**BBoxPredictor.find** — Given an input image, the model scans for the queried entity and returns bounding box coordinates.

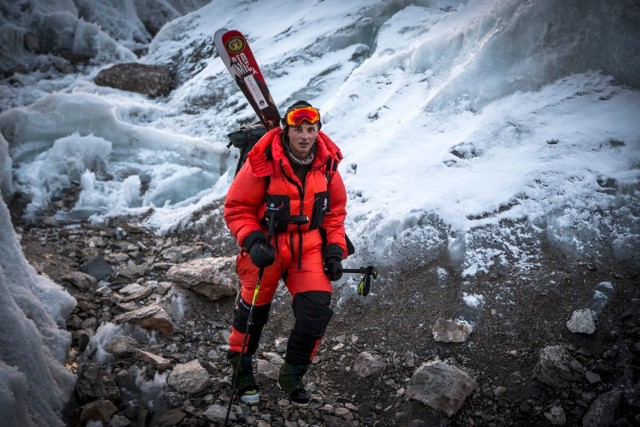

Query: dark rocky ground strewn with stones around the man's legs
[8,192,640,427]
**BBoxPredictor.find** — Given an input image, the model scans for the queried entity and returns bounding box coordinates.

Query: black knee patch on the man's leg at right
[292,291,333,339]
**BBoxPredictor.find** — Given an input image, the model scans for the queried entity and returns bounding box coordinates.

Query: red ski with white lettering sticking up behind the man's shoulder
[214,28,280,130]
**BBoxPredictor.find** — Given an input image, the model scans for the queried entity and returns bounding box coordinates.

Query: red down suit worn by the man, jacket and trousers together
[224,128,347,363]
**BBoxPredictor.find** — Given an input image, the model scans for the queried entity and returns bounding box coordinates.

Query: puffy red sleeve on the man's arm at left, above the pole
[224,162,267,245]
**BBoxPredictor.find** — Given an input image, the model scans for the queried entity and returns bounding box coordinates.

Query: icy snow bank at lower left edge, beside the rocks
[0,137,76,426]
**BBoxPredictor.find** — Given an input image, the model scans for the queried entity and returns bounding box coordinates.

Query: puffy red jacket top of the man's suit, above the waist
[224,128,347,258]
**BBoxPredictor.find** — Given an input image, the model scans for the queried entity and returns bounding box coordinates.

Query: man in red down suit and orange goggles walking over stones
[224,101,347,405]
